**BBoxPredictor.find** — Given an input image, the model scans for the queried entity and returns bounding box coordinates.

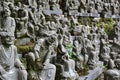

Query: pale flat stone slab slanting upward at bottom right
[79,62,103,80]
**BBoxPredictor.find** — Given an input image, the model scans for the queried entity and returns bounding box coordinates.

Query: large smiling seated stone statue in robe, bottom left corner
[0,34,27,80]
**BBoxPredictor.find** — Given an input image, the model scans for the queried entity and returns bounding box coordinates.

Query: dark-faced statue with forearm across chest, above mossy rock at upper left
[15,7,28,37]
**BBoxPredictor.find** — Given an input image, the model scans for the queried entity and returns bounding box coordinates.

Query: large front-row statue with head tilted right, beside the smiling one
[27,37,56,80]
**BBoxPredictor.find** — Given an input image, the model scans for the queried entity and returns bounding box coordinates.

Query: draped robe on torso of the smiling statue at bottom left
[0,45,18,80]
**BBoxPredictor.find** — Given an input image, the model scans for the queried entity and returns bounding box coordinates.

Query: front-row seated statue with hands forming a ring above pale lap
[55,44,78,80]
